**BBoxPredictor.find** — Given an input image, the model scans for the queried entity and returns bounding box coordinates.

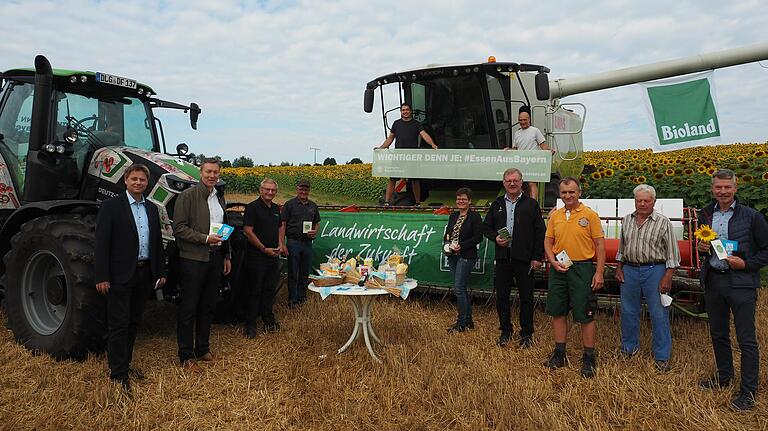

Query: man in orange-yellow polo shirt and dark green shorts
[544,177,605,377]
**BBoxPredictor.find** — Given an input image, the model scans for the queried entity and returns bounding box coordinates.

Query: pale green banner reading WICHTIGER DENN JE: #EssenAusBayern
[371,149,552,182]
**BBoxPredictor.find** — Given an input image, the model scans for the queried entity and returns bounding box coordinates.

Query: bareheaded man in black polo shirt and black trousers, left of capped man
[243,178,285,338]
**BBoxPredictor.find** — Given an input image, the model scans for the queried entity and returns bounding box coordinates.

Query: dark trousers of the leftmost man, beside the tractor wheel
[107,265,152,380]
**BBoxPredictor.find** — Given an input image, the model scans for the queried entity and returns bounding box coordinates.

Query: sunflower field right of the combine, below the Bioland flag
[580,143,768,214]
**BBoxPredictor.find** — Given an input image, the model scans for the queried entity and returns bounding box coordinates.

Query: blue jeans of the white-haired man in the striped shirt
[621,264,672,361]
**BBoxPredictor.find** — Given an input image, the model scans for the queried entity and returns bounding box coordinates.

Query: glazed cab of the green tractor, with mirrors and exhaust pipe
[0,65,200,202]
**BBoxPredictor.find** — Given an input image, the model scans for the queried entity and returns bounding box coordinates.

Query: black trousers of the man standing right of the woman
[493,260,534,337]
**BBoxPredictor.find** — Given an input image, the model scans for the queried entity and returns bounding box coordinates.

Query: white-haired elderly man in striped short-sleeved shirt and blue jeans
[616,184,680,372]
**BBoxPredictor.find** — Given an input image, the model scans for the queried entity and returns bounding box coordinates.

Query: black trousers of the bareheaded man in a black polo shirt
[245,253,280,329]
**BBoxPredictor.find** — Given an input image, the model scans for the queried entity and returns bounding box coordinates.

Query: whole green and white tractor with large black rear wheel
[0,56,201,358]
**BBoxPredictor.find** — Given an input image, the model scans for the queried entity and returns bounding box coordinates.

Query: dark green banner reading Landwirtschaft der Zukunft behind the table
[312,211,494,290]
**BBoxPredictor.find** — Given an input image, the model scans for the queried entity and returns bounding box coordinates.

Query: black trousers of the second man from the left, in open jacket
[176,251,224,363]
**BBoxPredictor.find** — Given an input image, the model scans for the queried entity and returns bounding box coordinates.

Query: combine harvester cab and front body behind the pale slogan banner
[364,57,586,206]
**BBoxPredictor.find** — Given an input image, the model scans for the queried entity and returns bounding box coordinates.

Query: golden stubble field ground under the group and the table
[0,290,768,431]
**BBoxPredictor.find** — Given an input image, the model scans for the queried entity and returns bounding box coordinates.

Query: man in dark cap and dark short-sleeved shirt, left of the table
[281,180,320,308]
